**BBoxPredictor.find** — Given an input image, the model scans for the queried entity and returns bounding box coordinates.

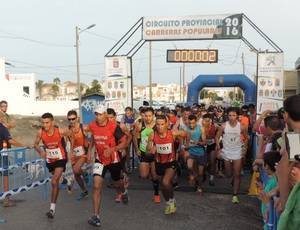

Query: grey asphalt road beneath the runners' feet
[0,171,262,230]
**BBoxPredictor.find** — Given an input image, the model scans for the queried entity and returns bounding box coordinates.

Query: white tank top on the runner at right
[222,121,242,152]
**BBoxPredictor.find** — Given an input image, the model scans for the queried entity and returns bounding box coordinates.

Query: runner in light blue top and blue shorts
[186,115,207,194]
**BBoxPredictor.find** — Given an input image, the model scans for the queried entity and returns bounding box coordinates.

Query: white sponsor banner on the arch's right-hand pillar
[257,53,284,114]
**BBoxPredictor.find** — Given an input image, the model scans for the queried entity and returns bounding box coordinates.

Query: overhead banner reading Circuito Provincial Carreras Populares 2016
[143,14,243,40]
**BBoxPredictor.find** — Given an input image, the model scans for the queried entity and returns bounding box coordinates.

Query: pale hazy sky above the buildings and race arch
[0,0,300,84]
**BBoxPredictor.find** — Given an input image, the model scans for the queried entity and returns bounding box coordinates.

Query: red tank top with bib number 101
[153,130,176,164]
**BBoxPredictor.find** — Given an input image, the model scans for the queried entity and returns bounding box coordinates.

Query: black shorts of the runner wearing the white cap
[93,160,122,181]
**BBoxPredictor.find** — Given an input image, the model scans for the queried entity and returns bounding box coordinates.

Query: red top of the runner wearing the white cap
[89,121,120,165]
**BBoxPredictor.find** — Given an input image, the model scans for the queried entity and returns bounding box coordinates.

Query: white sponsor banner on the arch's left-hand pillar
[105,56,131,114]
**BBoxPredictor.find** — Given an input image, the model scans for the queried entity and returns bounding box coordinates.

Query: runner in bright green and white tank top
[134,107,160,203]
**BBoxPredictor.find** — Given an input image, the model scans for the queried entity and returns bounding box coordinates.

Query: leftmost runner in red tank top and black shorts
[34,113,68,219]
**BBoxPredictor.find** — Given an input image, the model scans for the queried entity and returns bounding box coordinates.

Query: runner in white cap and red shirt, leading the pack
[85,105,128,227]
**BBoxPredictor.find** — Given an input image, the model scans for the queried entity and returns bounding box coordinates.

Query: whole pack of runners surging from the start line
[1,101,251,227]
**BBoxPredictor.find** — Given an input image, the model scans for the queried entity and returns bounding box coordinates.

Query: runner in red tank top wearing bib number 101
[147,115,186,215]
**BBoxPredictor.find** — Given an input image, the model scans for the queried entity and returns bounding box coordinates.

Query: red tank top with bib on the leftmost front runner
[41,127,67,163]
